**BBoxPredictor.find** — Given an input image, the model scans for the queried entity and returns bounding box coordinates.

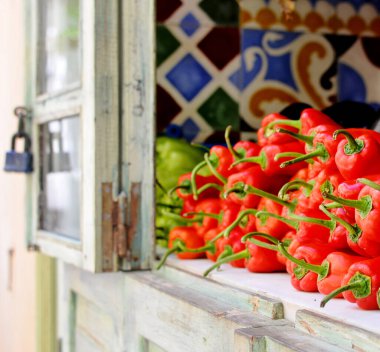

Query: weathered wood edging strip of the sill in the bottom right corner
[295,307,380,352]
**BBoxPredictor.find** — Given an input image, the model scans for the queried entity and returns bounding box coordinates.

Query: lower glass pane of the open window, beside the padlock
[39,116,81,239]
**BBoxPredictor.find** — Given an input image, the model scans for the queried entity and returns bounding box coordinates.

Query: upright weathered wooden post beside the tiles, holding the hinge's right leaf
[121,0,156,270]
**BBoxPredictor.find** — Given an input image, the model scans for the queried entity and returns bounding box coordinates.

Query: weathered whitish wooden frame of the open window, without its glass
[25,0,120,272]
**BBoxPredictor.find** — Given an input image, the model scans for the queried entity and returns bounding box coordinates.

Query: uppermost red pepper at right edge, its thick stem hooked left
[333,130,380,180]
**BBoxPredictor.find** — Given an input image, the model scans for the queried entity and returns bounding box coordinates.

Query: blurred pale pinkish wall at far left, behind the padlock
[0,0,36,352]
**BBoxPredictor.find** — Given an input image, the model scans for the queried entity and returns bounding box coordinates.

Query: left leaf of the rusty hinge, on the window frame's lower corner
[102,182,128,271]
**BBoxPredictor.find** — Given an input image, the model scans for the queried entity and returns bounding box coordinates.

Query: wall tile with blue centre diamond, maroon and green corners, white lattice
[157,23,240,142]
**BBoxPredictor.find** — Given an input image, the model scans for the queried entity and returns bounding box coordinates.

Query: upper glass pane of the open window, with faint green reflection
[37,0,81,95]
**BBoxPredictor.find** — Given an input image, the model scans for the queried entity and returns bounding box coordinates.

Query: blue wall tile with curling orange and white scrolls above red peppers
[240,29,352,132]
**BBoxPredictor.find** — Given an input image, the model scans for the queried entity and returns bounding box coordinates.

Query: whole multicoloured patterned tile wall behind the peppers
[157,0,380,142]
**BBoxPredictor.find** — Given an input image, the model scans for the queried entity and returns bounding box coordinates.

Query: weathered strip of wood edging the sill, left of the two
[156,264,284,319]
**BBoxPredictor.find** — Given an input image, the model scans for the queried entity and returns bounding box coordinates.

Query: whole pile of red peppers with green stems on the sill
[158,108,380,309]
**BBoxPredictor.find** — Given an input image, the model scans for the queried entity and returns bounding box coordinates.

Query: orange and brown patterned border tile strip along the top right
[240,0,380,36]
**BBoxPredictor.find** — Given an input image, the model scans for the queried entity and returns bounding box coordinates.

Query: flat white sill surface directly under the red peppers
[167,256,380,337]
